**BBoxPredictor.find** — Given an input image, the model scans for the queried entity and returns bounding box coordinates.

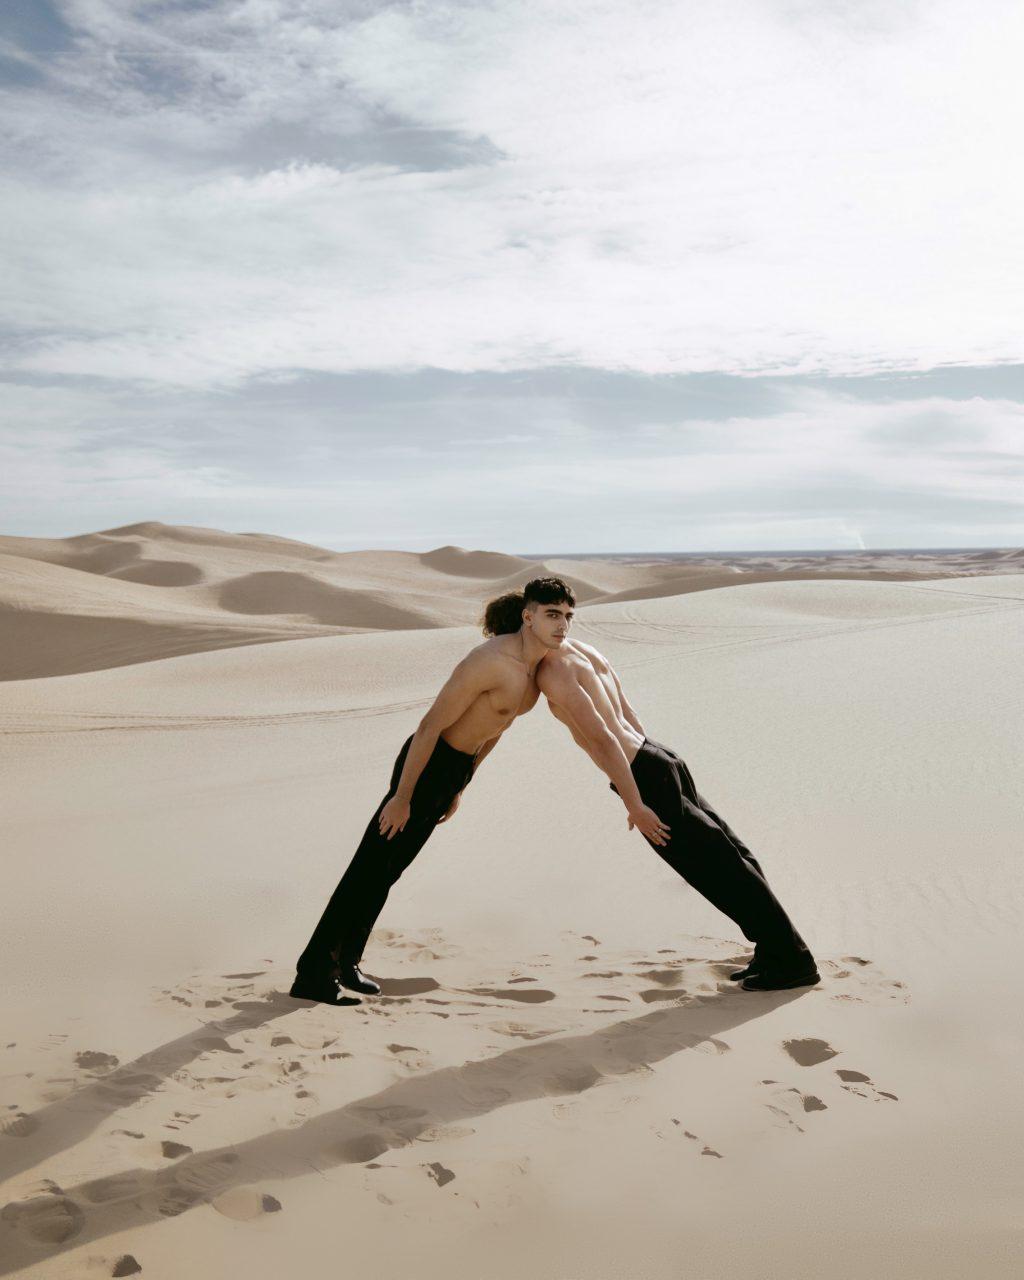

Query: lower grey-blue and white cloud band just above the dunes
[0,371,1024,552]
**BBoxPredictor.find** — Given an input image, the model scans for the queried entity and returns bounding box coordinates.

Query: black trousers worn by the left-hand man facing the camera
[296,736,476,978]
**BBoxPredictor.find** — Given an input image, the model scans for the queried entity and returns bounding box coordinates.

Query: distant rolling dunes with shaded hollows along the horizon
[0,521,1024,680]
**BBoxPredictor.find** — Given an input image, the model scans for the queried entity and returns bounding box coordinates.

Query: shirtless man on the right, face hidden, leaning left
[536,605,819,991]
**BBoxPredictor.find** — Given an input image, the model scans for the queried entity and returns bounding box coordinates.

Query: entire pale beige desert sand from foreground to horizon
[0,525,1024,1280]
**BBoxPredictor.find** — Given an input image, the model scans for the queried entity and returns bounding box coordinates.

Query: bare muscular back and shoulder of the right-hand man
[538,640,644,763]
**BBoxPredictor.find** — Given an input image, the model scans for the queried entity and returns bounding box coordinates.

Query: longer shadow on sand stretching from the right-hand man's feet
[0,991,805,1275]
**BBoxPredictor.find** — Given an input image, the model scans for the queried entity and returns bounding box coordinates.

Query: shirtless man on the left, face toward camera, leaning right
[289,577,575,1004]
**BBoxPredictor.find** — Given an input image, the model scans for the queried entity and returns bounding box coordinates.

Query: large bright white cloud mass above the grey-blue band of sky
[0,0,1024,389]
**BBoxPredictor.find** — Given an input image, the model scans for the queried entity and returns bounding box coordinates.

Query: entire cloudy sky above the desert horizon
[0,0,1024,552]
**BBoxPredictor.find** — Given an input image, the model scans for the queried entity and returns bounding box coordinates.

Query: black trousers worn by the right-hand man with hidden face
[612,737,812,968]
